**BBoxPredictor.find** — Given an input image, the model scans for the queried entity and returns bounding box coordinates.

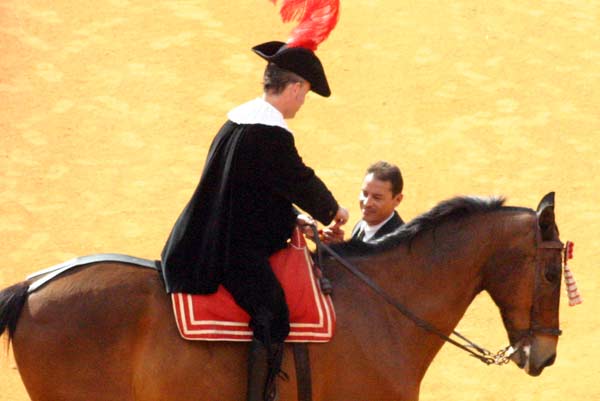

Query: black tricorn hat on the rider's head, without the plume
[252,41,331,97]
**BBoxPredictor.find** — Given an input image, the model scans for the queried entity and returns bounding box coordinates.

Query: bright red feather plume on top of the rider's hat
[271,0,340,51]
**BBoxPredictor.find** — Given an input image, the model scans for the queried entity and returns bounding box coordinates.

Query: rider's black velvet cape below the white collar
[162,121,338,294]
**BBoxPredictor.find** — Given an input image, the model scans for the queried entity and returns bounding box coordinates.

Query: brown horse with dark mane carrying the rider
[0,194,562,401]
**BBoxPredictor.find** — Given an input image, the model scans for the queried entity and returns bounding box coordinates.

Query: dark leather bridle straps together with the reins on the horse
[308,224,565,365]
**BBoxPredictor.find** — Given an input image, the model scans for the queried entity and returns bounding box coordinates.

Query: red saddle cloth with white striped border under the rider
[171,229,335,342]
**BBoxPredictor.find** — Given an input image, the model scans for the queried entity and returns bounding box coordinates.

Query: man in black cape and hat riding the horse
[162,42,348,400]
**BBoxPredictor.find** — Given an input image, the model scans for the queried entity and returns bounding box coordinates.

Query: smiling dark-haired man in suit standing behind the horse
[322,161,404,243]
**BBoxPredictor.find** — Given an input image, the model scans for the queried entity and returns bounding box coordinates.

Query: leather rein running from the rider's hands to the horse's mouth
[308,224,563,365]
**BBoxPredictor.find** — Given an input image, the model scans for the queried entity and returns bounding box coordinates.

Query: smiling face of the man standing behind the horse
[358,173,402,226]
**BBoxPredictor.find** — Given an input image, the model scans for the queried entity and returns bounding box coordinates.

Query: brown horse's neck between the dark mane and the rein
[359,215,498,320]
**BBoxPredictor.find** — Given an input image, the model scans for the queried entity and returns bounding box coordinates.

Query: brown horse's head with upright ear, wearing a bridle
[486,192,564,376]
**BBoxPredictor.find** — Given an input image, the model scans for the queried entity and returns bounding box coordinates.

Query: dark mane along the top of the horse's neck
[331,196,524,256]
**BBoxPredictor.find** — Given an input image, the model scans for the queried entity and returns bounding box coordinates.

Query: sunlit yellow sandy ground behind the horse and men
[0,0,600,401]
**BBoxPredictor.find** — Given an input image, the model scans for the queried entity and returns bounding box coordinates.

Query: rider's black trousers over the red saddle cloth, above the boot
[223,260,290,346]
